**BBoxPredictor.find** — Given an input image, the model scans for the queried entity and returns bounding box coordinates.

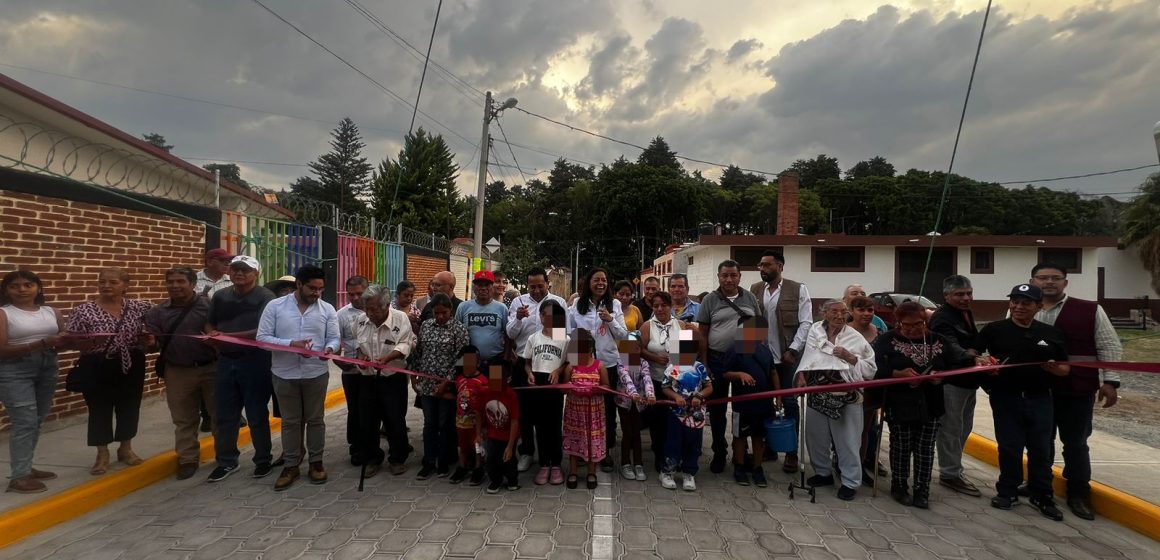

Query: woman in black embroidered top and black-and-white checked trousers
[873,301,985,509]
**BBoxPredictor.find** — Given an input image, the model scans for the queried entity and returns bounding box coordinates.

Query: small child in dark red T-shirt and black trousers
[476,364,520,494]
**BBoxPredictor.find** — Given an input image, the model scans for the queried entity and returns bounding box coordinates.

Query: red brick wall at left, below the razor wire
[0,189,205,429]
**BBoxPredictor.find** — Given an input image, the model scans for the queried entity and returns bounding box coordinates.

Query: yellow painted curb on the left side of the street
[0,387,346,548]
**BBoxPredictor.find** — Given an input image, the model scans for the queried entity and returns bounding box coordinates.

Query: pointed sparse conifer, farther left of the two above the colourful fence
[290,117,374,213]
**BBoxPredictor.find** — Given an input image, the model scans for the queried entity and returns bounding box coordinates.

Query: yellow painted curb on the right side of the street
[963,434,1160,540]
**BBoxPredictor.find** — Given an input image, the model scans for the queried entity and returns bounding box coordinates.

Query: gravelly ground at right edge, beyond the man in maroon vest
[1094,330,1160,448]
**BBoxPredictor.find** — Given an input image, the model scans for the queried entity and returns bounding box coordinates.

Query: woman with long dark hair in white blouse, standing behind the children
[567,268,629,473]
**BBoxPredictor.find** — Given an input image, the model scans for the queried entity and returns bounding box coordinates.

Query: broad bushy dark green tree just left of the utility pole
[370,128,464,239]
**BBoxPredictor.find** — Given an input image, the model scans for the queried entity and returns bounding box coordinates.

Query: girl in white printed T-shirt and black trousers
[523,299,568,486]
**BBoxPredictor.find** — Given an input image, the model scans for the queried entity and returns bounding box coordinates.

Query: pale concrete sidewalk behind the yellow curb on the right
[974,391,1160,506]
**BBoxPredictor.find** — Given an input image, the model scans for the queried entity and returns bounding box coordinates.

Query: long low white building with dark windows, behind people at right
[672,234,1158,320]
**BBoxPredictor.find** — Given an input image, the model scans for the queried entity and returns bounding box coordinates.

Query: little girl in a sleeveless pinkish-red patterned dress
[563,328,608,489]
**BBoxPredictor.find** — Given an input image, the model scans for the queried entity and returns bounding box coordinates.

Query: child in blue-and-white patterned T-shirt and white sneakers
[660,340,713,492]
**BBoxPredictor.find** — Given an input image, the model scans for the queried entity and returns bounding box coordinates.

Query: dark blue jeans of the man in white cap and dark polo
[213,350,274,467]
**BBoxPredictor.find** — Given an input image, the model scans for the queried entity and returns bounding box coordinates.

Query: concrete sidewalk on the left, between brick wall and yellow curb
[0,365,346,516]
